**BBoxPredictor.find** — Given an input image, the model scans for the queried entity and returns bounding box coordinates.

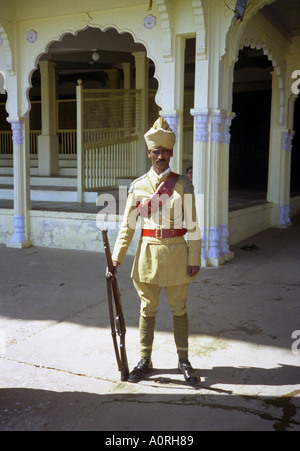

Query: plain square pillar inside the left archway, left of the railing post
[38,61,59,177]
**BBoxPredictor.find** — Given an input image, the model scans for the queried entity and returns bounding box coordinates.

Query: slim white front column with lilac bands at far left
[7,119,31,249]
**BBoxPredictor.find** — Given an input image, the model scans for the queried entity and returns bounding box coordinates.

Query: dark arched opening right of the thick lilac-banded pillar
[229,47,272,198]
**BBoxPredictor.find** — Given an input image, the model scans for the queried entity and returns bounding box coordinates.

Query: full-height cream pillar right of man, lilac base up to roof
[191,0,234,266]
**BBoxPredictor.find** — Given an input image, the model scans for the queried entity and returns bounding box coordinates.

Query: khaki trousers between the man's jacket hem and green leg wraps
[133,280,189,317]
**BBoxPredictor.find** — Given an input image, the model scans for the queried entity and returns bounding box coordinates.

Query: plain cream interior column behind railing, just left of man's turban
[133,52,149,174]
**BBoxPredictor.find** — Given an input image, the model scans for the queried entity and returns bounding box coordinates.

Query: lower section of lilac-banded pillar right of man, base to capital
[191,108,234,266]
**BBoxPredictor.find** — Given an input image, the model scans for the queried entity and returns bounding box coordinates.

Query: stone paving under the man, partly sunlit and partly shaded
[0,216,300,437]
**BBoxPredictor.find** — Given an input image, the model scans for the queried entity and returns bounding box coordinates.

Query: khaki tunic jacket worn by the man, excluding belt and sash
[112,169,201,286]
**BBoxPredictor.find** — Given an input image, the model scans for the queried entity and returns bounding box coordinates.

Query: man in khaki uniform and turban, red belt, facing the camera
[112,117,201,384]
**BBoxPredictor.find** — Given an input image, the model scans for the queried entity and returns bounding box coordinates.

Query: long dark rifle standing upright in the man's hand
[102,230,129,381]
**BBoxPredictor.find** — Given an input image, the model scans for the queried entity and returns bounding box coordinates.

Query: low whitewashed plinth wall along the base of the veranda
[0,202,300,255]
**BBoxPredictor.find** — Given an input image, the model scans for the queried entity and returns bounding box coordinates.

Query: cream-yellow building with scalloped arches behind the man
[0,0,300,266]
